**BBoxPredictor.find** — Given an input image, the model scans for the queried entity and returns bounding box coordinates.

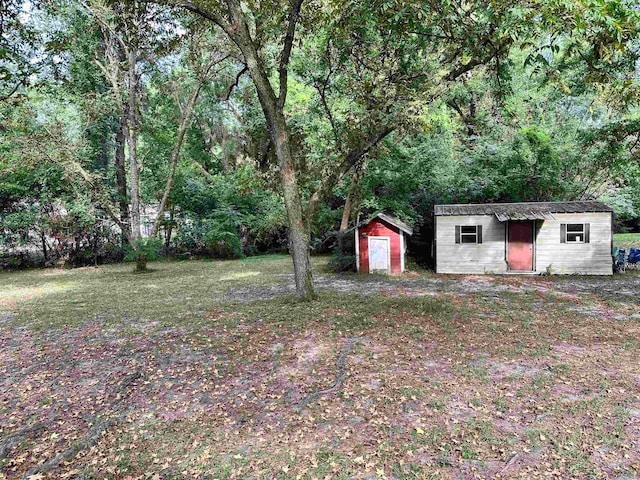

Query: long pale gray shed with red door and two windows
[434,202,613,275]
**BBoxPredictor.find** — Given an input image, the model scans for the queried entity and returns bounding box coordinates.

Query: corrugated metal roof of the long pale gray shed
[434,201,613,221]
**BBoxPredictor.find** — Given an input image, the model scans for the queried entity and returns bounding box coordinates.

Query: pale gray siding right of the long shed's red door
[536,212,613,275]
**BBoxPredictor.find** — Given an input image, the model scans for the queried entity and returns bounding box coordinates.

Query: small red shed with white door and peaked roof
[355,213,413,274]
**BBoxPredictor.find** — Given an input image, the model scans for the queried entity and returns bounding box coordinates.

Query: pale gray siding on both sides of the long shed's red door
[436,212,613,275]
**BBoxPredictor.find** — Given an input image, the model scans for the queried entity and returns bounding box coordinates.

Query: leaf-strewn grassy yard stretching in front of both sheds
[0,258,640,479]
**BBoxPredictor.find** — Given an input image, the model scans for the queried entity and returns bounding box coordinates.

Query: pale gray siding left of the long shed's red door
[436,215,507,273]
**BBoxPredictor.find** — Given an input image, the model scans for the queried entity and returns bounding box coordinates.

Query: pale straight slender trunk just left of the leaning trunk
[126,48,141,244]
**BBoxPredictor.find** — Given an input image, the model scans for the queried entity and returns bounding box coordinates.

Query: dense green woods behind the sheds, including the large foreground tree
[0,0,640,297]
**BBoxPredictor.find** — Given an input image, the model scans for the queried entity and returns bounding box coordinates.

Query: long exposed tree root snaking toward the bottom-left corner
[22,371,142,479]
